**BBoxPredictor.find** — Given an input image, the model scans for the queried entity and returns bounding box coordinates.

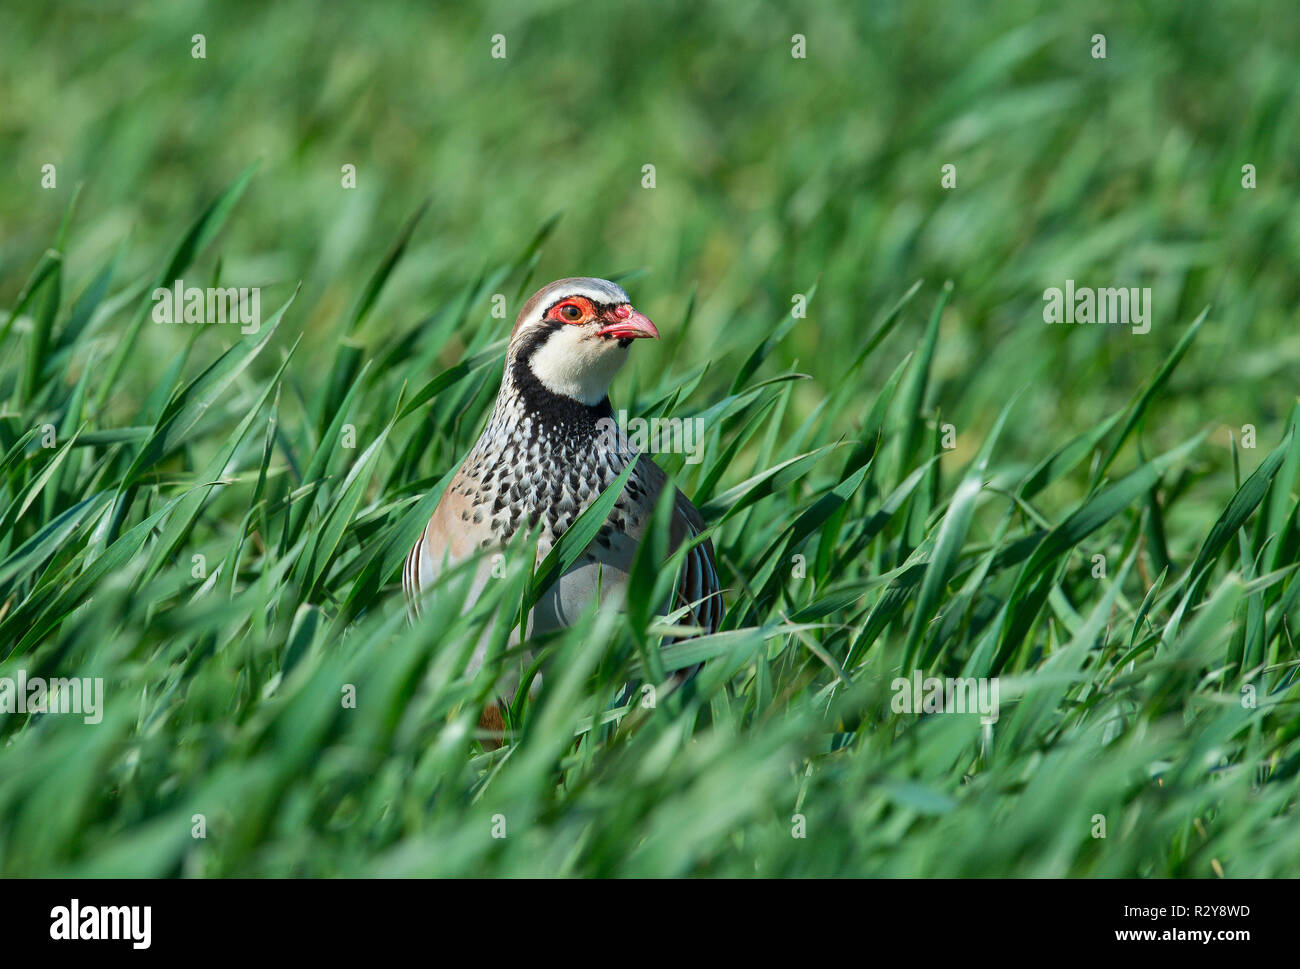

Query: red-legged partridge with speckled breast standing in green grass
[402,277,724,732]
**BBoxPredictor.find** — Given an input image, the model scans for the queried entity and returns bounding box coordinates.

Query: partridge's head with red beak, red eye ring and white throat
[506,277,659,406]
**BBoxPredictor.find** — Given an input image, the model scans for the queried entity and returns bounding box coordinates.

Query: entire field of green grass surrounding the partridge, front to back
[0,3,1300,877]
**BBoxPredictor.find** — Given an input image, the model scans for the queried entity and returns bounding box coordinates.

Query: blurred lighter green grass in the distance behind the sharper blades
[0,1,1300,454]
